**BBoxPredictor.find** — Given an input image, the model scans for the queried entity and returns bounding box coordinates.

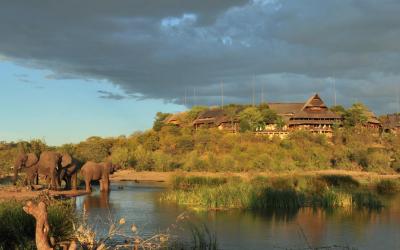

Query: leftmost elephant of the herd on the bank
[14,153,39,185]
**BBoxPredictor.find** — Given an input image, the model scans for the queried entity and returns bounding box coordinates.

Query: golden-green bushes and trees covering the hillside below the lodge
[0,102,400,175]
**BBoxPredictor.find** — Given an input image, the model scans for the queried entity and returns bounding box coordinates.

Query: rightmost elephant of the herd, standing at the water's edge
[81,161,117,193]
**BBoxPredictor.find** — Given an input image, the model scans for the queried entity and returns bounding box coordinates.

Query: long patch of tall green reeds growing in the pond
[161,176,383,211]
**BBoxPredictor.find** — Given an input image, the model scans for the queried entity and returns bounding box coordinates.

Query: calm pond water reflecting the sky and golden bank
[76,182,400,250]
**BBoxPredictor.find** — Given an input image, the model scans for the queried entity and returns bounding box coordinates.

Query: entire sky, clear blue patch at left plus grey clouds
[0,0,400,145]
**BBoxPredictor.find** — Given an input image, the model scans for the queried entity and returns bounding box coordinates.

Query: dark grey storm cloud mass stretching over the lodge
[0,0,400,112]
